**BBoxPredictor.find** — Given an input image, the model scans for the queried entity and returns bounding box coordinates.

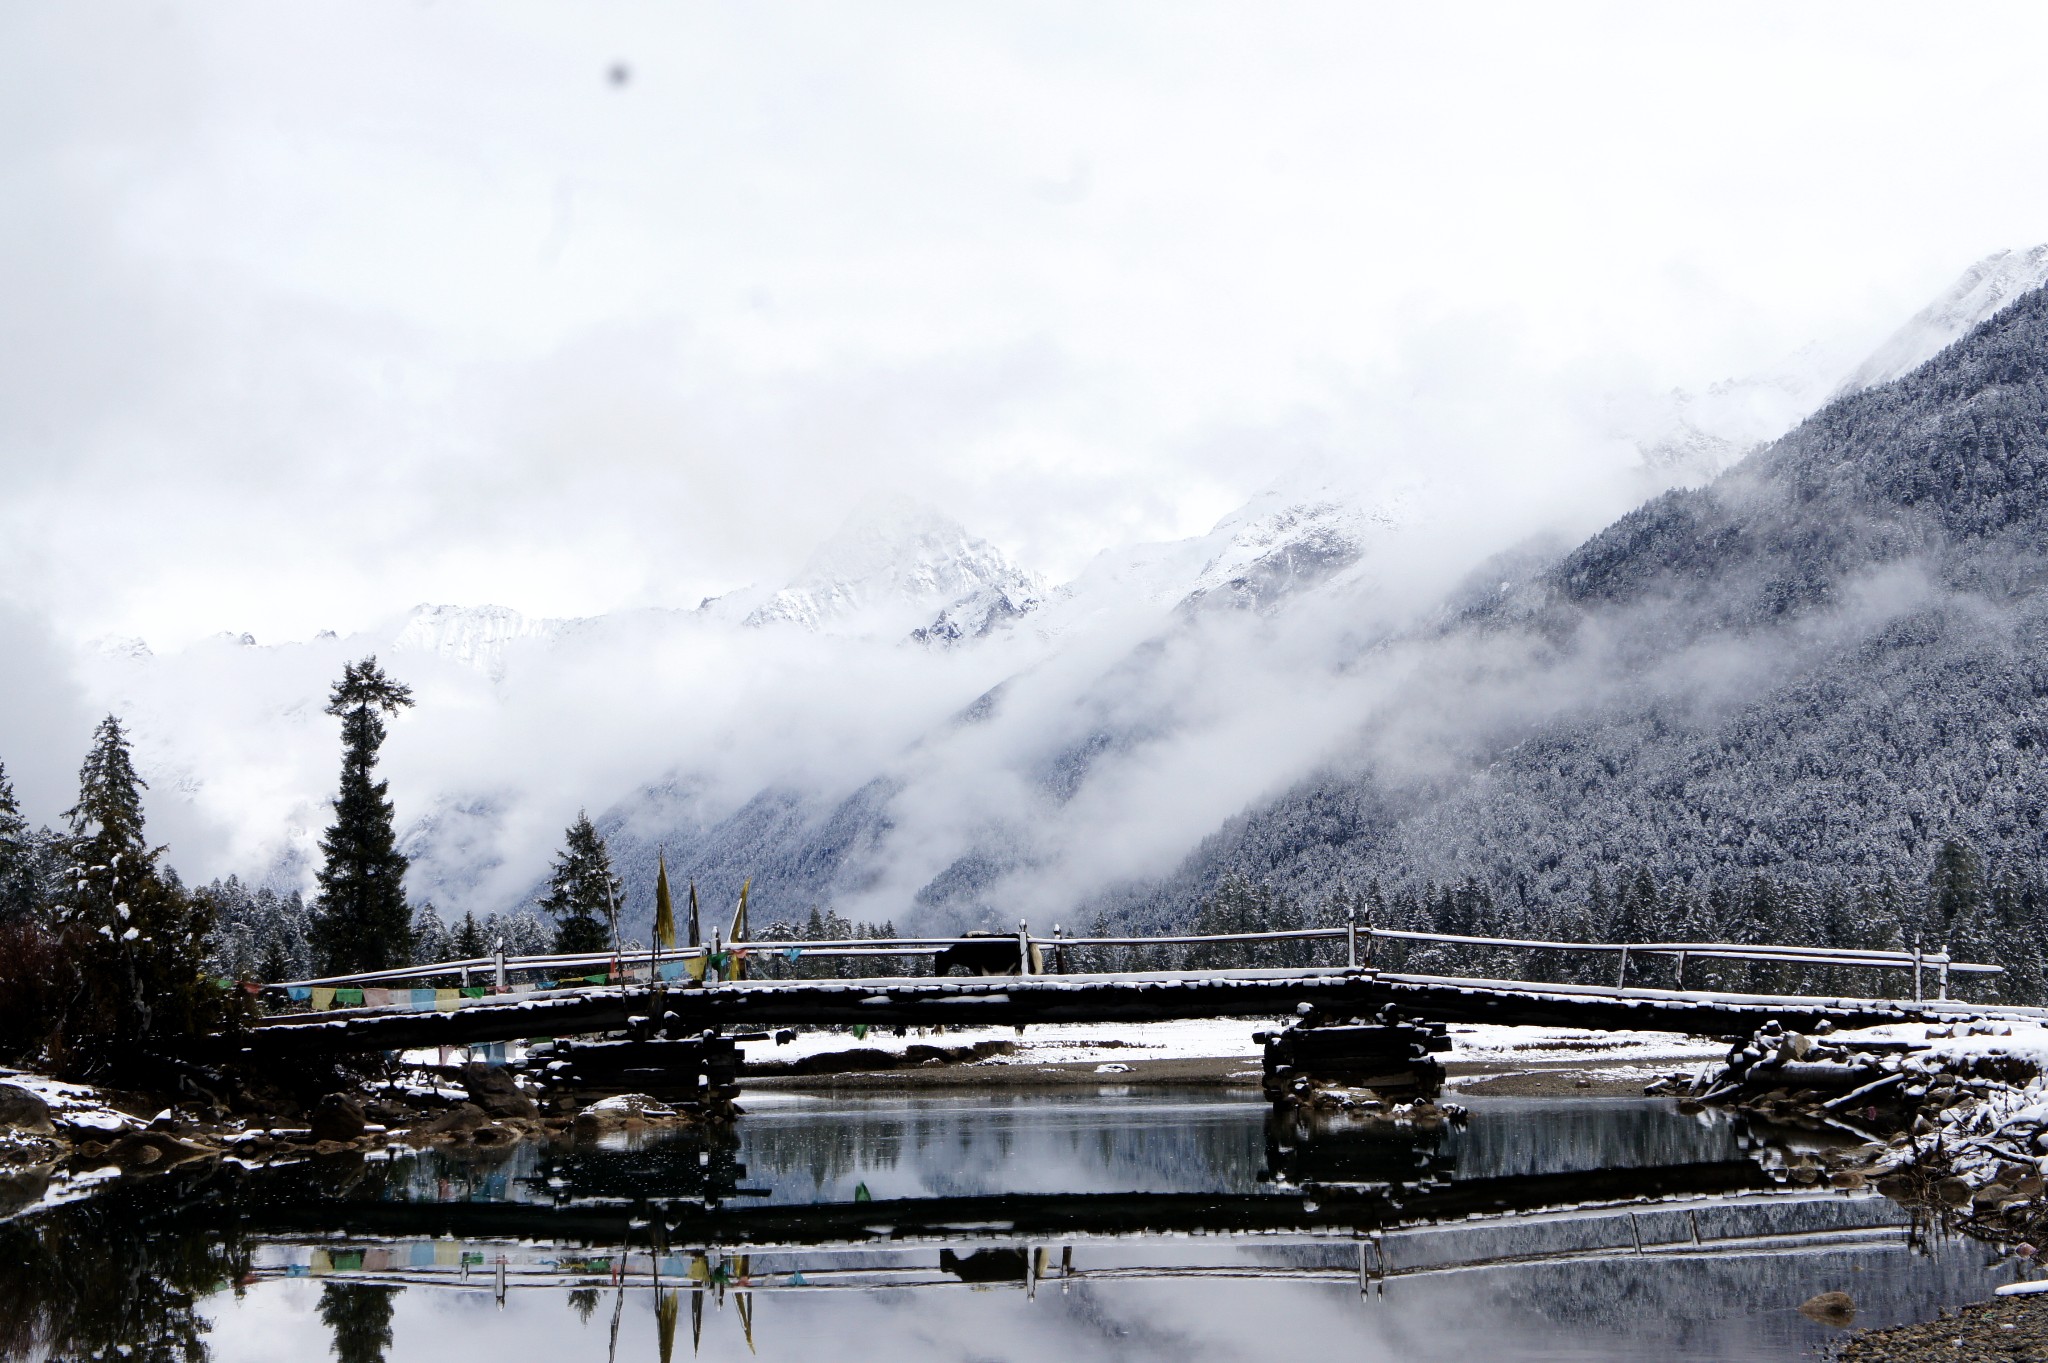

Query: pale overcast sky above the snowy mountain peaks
[0,0,2048,647]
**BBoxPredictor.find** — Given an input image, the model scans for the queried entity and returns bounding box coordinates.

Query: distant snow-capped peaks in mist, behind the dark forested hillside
[59,248,2048,925]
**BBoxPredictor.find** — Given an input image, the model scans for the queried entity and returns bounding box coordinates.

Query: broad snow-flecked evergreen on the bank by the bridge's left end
[57,714,225,1072]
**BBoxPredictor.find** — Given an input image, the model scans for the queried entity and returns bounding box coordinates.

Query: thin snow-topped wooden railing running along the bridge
[264,919,2003,1007]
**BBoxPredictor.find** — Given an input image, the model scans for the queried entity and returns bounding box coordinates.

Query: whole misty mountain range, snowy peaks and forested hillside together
[44,250,2048,941]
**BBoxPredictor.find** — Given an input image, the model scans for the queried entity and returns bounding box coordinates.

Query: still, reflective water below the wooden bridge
[0,1093,2015,1363]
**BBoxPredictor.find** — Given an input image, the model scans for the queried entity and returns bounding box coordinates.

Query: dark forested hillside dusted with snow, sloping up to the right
[1096,291,2048,961]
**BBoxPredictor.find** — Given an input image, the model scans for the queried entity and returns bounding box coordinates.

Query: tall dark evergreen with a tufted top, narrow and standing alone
[313,657,412,974]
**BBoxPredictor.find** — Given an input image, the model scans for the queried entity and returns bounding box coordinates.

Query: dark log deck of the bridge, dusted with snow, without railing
[228,968,2048,1056]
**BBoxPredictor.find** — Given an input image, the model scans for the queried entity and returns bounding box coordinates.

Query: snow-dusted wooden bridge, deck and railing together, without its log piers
[238,923,2023,1056]
